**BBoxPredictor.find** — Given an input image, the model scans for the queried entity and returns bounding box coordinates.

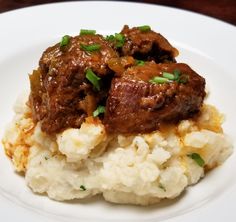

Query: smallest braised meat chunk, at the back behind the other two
[121,25,178,63]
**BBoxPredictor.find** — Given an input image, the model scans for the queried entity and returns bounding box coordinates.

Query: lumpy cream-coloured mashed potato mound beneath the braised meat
[3,92,232,205]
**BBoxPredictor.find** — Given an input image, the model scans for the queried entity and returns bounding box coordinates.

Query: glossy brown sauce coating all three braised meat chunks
[29,26,205,134]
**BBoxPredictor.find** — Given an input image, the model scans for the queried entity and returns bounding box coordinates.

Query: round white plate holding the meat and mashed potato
[0,2,236,222]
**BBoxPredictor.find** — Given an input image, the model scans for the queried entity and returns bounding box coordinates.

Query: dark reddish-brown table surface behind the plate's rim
[0,0,236,25]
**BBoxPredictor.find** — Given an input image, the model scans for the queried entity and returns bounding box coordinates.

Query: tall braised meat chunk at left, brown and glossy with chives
[30,34,118,133]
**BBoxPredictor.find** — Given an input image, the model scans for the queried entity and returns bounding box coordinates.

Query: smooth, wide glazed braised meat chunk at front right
[104,62,205,134]
